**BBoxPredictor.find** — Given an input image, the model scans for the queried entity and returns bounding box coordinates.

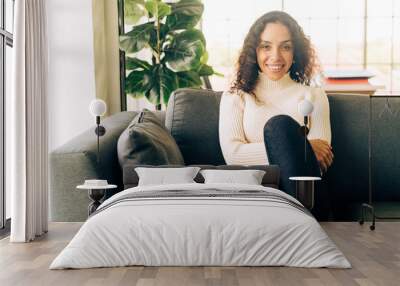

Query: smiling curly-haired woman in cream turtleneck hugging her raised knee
[219,11,333,219]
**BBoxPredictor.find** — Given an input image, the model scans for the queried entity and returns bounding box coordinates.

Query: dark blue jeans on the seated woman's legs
[264,115,330,220]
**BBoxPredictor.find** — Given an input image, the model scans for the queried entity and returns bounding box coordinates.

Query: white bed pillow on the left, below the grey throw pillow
[135,167,200,186]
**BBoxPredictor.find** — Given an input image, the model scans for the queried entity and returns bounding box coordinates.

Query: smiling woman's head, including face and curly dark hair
[233,11,317,92]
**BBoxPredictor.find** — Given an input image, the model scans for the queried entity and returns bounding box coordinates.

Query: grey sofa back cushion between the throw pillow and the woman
[165,88,225,165]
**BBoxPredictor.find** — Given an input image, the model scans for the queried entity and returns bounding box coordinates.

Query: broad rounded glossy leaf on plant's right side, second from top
[164,29,205,72]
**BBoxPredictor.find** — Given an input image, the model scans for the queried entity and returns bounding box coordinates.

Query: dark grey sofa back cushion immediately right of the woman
[326,94,369,205]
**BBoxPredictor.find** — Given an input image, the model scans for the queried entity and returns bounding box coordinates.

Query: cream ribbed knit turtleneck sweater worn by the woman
[219,73,331,165]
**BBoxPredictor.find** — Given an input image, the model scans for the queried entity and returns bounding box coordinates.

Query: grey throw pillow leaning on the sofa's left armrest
[117,109,184,168]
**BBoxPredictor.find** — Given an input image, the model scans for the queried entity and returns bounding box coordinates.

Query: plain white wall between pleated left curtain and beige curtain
[47,0,95,151]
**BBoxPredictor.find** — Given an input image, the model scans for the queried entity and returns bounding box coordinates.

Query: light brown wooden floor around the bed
[0,222,400,286]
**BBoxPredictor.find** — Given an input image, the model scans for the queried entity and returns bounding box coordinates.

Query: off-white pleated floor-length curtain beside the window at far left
[10,0,48,242]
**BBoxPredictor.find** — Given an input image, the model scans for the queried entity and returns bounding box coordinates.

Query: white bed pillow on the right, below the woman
[200,170,265,185]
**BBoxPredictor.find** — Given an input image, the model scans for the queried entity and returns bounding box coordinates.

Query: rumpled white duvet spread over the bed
[50,184,351,269]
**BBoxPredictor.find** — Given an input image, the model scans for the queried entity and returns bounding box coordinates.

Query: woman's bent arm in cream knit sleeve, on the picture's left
[219,92,268,165]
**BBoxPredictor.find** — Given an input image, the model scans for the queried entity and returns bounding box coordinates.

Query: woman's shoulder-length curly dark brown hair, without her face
[231,11,318,94]
